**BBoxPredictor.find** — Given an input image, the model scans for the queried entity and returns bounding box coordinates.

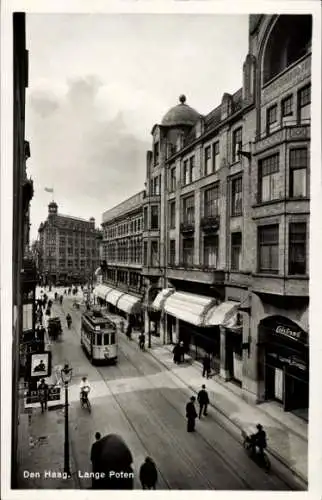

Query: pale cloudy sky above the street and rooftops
[26,14,248,239]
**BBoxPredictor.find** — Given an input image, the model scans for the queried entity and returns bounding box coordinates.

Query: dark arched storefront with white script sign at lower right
[259,316,309,419]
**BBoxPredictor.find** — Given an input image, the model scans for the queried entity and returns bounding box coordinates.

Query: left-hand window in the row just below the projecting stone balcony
[259,153,280,202]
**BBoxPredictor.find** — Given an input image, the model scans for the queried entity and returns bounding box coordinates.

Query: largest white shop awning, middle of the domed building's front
[164,292,215,326]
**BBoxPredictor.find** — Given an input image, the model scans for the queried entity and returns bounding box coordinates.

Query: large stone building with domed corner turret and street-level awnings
[142,15,312,415]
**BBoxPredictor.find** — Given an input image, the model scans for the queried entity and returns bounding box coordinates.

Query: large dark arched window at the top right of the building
[263,15,312,84]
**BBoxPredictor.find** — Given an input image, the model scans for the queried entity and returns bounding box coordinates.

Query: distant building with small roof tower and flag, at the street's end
[38,201,102,285]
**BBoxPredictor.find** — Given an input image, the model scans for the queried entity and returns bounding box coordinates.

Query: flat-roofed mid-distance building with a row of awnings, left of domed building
[95,191,145,323]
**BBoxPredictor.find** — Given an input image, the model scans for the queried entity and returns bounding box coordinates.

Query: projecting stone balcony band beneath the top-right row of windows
[254,124,311,155]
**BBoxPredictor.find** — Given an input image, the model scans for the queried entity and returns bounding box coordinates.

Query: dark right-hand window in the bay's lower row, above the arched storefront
[288,222,306,274]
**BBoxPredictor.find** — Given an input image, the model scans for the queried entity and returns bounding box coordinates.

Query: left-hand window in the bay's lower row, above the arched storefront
[258,224,279,274]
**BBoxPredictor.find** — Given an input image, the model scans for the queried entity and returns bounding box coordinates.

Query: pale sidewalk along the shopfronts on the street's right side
[133,332,308,483]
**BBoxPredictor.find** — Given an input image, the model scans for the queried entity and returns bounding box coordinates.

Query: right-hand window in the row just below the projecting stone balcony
[290,148,308,198]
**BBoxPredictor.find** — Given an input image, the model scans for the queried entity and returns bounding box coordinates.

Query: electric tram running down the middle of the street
[81,309,117,364]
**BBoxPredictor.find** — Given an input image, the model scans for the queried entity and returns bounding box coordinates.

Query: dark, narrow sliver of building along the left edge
[8,13,37,488]
